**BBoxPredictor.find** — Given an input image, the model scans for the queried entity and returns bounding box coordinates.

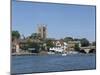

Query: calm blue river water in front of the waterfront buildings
[11,54,96,74]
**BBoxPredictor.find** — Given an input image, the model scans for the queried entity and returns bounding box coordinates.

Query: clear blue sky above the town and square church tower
[12,1,96,41]
